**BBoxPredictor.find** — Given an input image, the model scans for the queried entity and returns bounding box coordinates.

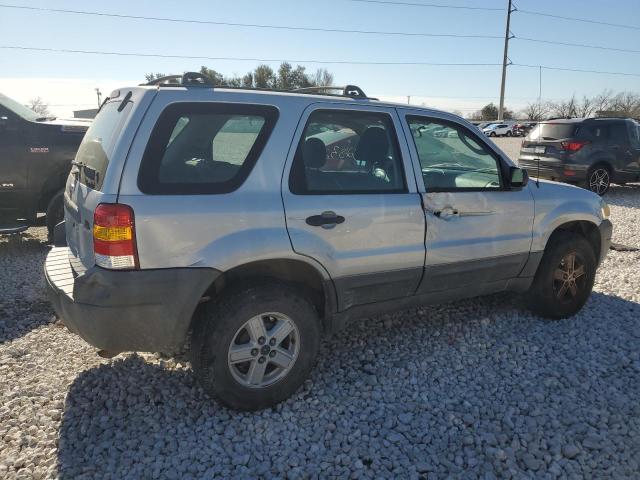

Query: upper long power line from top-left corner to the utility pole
[0,3,502,39]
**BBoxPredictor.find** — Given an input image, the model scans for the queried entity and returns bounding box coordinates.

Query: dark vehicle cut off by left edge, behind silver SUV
[0,94,90,234]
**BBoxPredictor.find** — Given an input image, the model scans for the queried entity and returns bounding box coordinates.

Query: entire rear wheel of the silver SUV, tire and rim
[191,282,320,410]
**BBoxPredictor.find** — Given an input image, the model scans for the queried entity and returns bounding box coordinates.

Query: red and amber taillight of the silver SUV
[93,203,139,270]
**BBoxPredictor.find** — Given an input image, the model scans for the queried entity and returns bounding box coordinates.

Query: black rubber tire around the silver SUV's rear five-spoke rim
[191,281,321,411]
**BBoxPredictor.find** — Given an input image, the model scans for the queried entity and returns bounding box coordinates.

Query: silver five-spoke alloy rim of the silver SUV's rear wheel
[227,312,300,388]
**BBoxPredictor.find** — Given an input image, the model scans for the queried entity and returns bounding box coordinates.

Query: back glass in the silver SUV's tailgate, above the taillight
[76,99,132,190]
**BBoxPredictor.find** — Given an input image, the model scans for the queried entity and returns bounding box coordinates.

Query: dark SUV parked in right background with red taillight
[518,118,640,195]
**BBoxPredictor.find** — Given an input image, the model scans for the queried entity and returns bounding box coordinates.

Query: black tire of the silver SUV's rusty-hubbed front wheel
[527,231,597,320]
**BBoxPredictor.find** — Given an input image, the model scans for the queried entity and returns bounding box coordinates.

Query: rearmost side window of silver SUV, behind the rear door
[138,103,278,195]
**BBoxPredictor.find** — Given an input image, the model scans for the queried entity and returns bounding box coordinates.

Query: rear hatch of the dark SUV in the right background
[520,122,580,164]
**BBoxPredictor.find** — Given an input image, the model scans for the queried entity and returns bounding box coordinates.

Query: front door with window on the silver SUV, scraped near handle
[403,110,534,293]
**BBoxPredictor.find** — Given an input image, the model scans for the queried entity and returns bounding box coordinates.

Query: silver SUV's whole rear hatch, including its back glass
[64,90,144,274]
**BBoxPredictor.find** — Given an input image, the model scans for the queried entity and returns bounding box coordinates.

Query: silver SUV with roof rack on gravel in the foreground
[45,75,612,410]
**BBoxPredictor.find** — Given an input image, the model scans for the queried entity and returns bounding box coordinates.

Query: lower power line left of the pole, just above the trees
[0,45,501,67]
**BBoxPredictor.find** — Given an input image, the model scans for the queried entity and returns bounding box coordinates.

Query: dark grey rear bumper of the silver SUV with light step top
[45,247,220,353]
